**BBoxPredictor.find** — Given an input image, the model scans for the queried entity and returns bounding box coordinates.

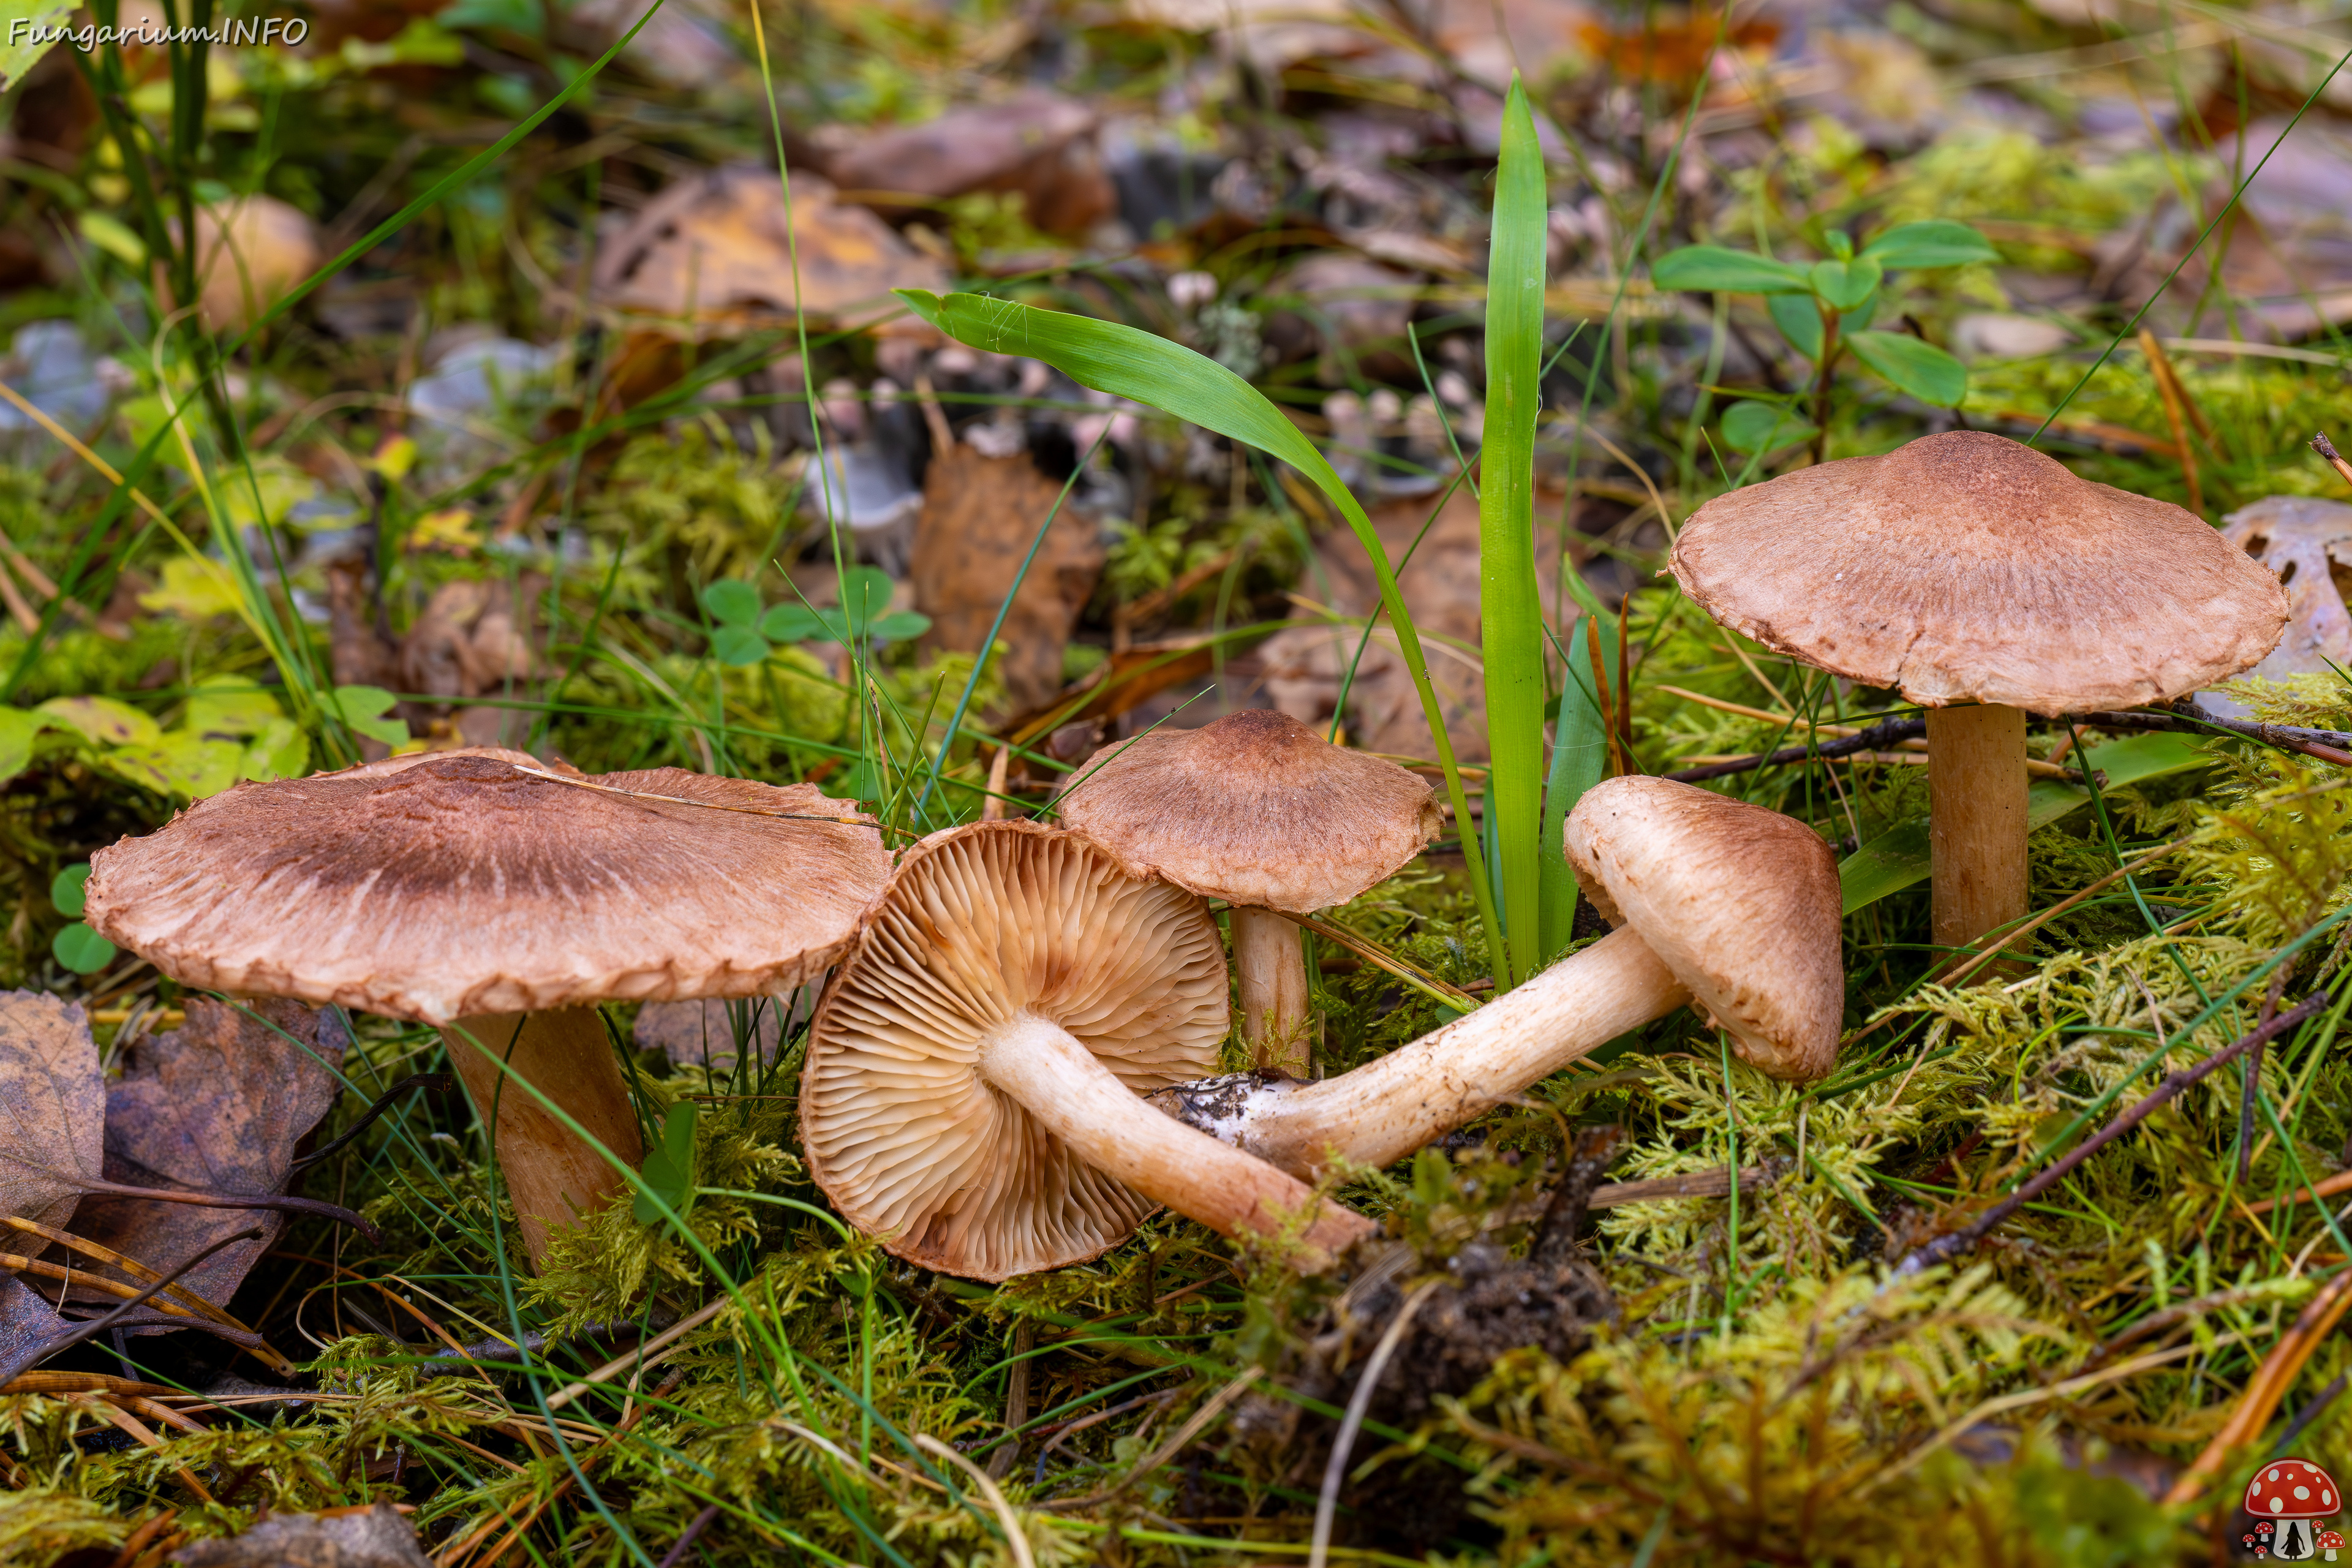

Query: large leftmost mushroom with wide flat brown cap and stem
[85,757,889,1265]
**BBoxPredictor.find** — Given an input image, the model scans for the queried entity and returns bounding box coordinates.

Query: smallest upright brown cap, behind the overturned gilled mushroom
[1058,707,1444,914]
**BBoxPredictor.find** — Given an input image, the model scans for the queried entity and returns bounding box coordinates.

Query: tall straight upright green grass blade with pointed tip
[1477,80,1548,990]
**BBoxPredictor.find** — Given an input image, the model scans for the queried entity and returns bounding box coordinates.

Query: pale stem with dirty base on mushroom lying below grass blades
[1153,926,1691,1180]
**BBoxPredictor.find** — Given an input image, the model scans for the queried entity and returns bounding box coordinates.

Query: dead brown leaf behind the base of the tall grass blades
[1258,486,1559,762]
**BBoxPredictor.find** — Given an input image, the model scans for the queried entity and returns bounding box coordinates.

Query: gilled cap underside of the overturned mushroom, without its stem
[800,823,1227,1281]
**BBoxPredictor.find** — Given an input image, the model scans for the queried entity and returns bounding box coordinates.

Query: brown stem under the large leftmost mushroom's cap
[442,1006,644,1270]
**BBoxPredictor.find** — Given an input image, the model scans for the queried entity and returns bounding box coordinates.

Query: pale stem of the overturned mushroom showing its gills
[981,1013,1374,1267]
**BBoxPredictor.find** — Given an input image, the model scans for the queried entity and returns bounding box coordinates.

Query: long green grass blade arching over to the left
[896,289,1507,985]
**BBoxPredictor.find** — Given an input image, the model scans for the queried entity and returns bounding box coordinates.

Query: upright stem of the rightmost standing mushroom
[1926,703,2030,978]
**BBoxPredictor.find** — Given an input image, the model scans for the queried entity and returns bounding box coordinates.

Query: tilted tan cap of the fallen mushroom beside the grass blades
[1566,778,1846,1079]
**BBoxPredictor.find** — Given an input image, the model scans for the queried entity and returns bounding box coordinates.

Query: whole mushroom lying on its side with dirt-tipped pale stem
[1153,776,1846,1180]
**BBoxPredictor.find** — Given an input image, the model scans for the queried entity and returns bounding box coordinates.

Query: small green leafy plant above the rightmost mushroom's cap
[1649,219,1997,456]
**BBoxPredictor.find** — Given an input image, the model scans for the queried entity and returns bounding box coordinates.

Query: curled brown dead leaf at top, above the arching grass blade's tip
[823,89,1117,239]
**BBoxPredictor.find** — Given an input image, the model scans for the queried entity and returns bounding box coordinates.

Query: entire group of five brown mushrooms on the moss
[87,432,2286,1281]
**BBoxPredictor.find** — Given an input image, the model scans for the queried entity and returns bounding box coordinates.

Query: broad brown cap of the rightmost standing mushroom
[1670,430,2286,715]
